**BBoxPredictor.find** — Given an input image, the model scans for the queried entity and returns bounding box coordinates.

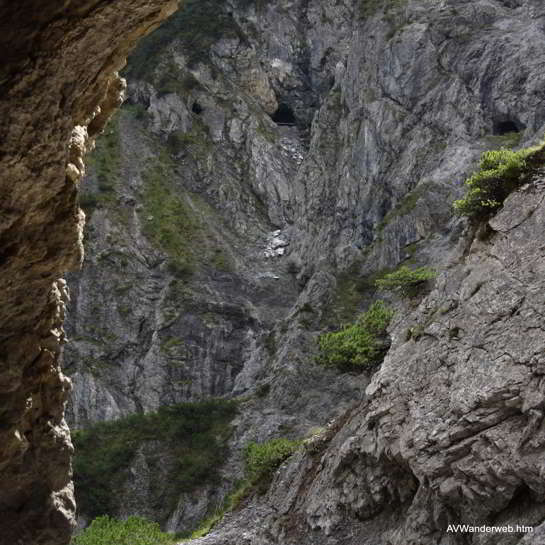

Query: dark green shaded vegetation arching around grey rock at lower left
[73,399,237,517]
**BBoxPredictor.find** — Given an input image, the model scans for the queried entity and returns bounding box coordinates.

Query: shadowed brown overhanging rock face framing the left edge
[0,0,177,545]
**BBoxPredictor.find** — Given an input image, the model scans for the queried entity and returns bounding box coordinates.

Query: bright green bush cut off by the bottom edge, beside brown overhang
[70,516,176,545]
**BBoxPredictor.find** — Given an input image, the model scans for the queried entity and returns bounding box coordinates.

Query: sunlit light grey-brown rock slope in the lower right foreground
[192,177,545,545]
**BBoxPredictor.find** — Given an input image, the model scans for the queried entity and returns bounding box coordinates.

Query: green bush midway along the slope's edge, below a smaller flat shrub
[317,301,394,371]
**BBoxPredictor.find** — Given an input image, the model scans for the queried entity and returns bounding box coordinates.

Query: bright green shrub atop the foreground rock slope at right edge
[454,143,544,220]
